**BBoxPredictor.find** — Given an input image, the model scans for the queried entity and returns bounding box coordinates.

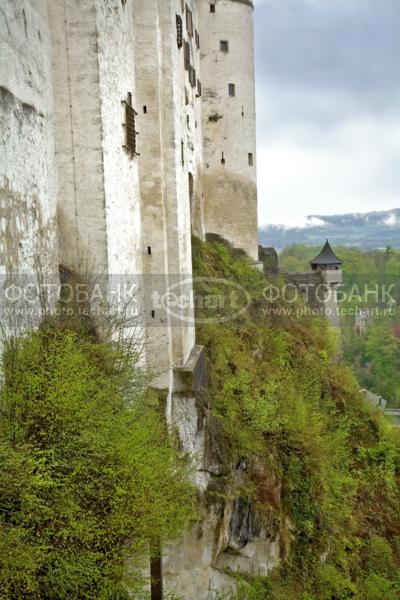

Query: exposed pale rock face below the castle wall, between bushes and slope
[164,394,287,600]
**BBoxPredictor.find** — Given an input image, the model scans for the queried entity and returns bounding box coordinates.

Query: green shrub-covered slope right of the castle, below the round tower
[194,241,400,600]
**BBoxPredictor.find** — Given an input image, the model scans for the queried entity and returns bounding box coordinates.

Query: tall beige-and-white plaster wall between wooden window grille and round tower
[133,0,201,387]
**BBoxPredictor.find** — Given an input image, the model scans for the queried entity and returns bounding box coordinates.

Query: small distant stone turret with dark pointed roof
[310,240,343,329]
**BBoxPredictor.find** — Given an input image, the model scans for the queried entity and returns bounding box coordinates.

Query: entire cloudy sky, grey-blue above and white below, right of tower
[255,0,400,225]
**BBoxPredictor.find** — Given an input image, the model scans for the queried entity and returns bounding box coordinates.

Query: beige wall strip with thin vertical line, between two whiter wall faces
[49,0,108,274]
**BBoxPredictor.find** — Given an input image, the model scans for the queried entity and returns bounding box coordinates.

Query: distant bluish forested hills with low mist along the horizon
[259,208,400,250]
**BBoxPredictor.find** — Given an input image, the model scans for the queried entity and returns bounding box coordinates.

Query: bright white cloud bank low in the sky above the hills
[258,118,400,225]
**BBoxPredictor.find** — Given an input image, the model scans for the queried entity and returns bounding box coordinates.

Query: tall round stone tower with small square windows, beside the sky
[200,0,258,261]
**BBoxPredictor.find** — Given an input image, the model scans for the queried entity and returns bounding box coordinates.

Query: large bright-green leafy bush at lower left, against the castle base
[0,322,194,600]
